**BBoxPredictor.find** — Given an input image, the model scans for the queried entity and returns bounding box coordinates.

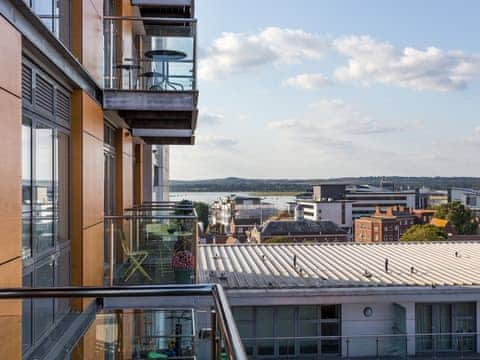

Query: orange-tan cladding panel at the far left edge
[0,16,23,359]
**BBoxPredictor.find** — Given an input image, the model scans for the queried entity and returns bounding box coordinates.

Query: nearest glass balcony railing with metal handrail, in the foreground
[0,285,247,360]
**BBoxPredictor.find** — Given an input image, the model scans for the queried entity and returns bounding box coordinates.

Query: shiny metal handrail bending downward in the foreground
[0,284,247,360]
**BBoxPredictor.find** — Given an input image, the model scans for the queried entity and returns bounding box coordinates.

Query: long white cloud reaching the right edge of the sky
[333,36,480,91]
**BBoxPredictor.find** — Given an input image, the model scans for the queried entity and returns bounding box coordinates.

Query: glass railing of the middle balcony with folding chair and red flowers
[105,202,198,285]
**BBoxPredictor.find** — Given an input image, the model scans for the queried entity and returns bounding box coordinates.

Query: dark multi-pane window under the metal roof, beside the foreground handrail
[233,305,340,359]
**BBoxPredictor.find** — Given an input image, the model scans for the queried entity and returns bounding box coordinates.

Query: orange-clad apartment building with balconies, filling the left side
[0,0,248,359]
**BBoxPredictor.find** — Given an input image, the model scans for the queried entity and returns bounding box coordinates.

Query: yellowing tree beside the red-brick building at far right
[435,201,478,235]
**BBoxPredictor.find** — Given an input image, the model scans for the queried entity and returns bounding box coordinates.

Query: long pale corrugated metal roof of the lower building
[199,242,480,289]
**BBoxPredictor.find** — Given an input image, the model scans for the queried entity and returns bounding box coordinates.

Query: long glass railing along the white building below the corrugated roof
[242,329,480,360]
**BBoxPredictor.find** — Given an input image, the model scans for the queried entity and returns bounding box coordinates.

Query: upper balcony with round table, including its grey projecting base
[103,15,198,145]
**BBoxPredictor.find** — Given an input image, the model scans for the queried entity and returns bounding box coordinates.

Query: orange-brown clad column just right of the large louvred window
[71,90,104,298]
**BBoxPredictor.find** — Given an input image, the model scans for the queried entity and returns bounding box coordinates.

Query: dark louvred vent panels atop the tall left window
[22,58,72,126]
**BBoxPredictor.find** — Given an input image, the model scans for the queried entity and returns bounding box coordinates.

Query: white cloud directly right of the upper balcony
[199,27,329,80]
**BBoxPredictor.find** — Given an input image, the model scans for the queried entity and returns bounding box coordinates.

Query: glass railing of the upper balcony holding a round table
[104,16,196,91]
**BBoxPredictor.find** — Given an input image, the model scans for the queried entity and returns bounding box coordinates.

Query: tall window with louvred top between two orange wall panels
[22,59,71,357]
